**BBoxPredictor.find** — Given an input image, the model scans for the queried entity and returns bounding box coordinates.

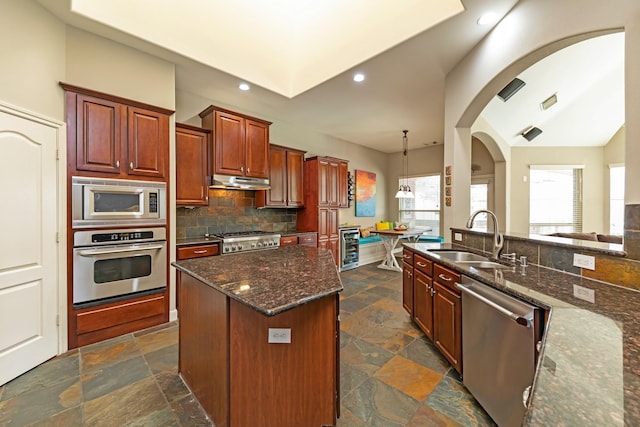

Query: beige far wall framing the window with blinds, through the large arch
[509,147,609,234]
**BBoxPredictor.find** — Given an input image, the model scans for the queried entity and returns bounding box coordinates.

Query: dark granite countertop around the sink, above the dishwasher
[404,243,640,426]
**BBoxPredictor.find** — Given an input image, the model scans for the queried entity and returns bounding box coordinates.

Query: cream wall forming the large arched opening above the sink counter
[444,0,640,241]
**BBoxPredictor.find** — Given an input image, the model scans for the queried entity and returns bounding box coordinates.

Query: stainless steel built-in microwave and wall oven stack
[71,177,167,308]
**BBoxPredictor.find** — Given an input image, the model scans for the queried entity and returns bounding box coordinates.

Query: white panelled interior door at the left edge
[0,104,60,385]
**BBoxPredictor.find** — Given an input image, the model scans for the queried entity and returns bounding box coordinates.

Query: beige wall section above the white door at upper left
[0,0,65,121]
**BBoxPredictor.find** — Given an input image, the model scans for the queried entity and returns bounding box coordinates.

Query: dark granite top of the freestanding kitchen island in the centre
[172,245,343,316]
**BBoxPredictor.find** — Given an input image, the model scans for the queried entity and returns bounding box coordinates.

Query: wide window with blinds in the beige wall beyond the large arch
[529,165,582,234]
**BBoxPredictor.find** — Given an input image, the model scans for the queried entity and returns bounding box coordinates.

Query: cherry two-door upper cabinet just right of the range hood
[256,144,305,208]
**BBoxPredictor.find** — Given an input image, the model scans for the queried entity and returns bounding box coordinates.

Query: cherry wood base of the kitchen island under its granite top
[178,272,339,427]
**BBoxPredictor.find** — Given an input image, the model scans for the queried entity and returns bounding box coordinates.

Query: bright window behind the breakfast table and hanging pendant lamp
[398,175,440,236]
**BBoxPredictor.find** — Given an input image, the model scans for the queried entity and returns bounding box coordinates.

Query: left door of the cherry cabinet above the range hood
[214,111,245,176]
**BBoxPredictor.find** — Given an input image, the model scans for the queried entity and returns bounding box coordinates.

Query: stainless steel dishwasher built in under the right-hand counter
[456,276,542,427]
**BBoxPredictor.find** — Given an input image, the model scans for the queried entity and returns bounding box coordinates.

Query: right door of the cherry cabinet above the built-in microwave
[126,107,169,178]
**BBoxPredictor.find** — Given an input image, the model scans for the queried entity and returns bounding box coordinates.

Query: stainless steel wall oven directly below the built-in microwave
[73,227,167,304]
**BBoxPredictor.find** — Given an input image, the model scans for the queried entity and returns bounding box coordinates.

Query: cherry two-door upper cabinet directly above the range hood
[200,105,271,178]
